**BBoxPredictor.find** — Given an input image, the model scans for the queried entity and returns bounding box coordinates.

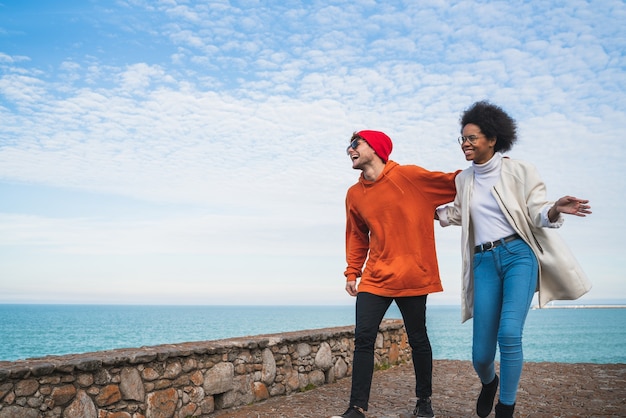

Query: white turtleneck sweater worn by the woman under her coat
[470,152,515,245]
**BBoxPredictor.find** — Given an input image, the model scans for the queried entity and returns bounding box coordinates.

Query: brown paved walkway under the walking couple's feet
[208,360,626,418]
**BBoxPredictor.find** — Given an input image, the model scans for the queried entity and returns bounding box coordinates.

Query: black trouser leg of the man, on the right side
[395,295,433,398]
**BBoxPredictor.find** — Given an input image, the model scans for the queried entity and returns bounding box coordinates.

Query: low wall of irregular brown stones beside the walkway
[0,320,411,418]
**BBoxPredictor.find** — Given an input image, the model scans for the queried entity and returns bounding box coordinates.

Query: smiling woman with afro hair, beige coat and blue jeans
[436,101,591,418]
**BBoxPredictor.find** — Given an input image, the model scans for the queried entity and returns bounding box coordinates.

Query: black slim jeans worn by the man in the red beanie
[350,292,433,410]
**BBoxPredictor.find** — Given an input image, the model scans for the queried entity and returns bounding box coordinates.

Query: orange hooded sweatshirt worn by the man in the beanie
[344,160,458,297]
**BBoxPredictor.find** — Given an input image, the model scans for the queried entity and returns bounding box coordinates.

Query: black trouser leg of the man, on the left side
[350,292,393,411]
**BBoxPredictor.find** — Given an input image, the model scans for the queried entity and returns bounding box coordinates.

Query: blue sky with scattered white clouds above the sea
[0,0,626,305]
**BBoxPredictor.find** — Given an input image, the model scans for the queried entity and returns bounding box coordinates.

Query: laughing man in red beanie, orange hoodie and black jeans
[335,130,458,418]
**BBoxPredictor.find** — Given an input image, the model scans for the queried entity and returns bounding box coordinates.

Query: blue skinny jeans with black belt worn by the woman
[472,239,539,405]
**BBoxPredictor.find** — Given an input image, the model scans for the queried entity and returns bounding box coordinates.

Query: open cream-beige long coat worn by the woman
[440,158,591,322]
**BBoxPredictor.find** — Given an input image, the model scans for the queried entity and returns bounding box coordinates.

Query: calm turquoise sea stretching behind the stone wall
[0,304,626,363]
